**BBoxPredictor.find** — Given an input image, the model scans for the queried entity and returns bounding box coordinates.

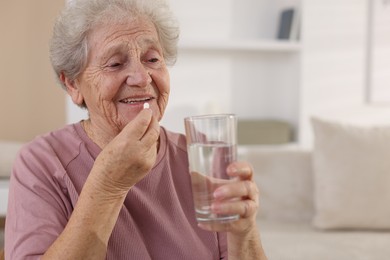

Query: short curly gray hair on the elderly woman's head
[50,0,179,87]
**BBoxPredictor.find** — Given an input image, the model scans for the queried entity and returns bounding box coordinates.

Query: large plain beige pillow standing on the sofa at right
[312,118,390,229]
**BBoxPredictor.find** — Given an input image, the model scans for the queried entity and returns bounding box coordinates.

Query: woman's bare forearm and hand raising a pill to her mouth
[42,109,160,259]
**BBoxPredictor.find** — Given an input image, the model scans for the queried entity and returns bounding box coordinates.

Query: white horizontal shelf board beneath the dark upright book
[179,39,301,52]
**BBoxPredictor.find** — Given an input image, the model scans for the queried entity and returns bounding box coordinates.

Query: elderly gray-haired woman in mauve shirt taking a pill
[5,0,265,260]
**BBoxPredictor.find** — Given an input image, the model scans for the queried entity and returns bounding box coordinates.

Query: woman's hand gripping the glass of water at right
[199,162,259,236]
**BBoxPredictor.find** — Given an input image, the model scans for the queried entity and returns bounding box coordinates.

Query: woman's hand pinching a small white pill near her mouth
[91,109,160,195]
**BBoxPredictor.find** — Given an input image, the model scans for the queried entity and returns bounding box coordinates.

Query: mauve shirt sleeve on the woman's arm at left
[5,145,72,259]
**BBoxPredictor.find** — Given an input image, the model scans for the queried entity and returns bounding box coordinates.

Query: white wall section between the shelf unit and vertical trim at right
[299,0,367,143]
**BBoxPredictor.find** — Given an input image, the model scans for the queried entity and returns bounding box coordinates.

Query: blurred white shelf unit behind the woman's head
[162,0,301,136]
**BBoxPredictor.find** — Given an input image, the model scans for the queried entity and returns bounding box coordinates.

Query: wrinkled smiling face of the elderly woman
[77,19,169,132]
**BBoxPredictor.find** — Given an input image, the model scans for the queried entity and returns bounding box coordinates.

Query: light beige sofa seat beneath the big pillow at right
[258,219,390,260]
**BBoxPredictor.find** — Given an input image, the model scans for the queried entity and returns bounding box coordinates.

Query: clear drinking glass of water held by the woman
[184,114,239,223]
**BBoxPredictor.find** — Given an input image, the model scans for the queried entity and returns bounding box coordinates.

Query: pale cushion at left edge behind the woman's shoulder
[0,141,22,178]
